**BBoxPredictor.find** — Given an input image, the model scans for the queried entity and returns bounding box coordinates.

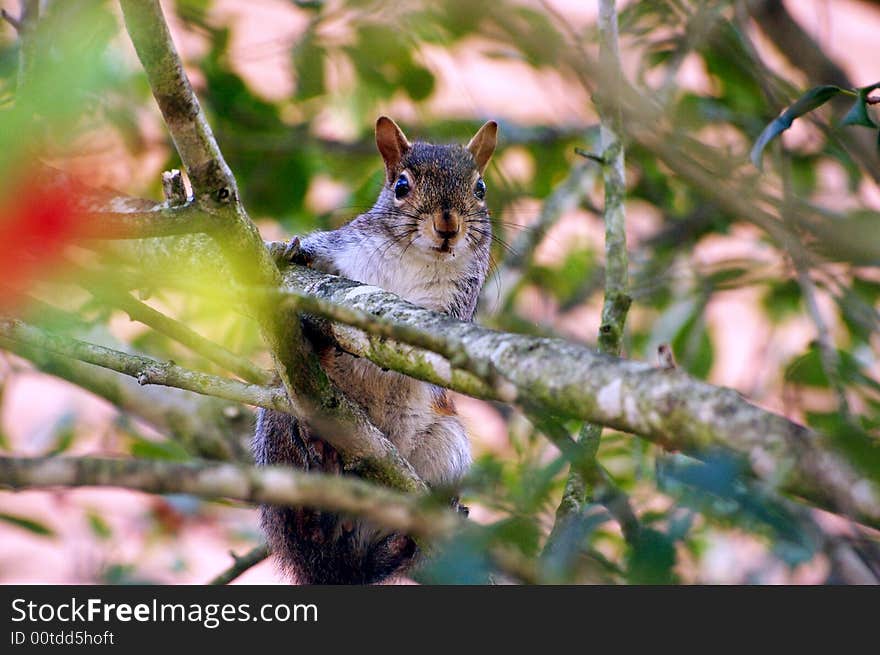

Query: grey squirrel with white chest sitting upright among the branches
[253,116,498,584]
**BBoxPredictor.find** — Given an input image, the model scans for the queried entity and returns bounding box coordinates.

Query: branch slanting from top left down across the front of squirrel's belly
[120,0,424,490]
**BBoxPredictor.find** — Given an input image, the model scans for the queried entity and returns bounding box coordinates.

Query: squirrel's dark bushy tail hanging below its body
[254,410,416,584]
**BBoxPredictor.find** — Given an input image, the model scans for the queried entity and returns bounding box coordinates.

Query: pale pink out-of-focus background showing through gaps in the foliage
[0,0,880,584]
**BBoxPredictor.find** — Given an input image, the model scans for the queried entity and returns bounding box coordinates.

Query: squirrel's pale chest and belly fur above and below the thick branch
[303,230,482,484]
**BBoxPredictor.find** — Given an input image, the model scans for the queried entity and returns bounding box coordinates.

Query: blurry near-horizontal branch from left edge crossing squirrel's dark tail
[0,457,463,539]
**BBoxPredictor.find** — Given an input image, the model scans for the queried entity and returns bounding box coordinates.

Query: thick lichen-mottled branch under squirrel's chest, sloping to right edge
[285,267,880,525]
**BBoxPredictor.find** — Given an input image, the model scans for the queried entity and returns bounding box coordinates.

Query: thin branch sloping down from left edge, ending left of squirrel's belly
[0,318,291,412]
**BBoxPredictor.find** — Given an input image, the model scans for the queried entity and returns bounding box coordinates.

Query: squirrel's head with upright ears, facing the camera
[376,116,498,257]
